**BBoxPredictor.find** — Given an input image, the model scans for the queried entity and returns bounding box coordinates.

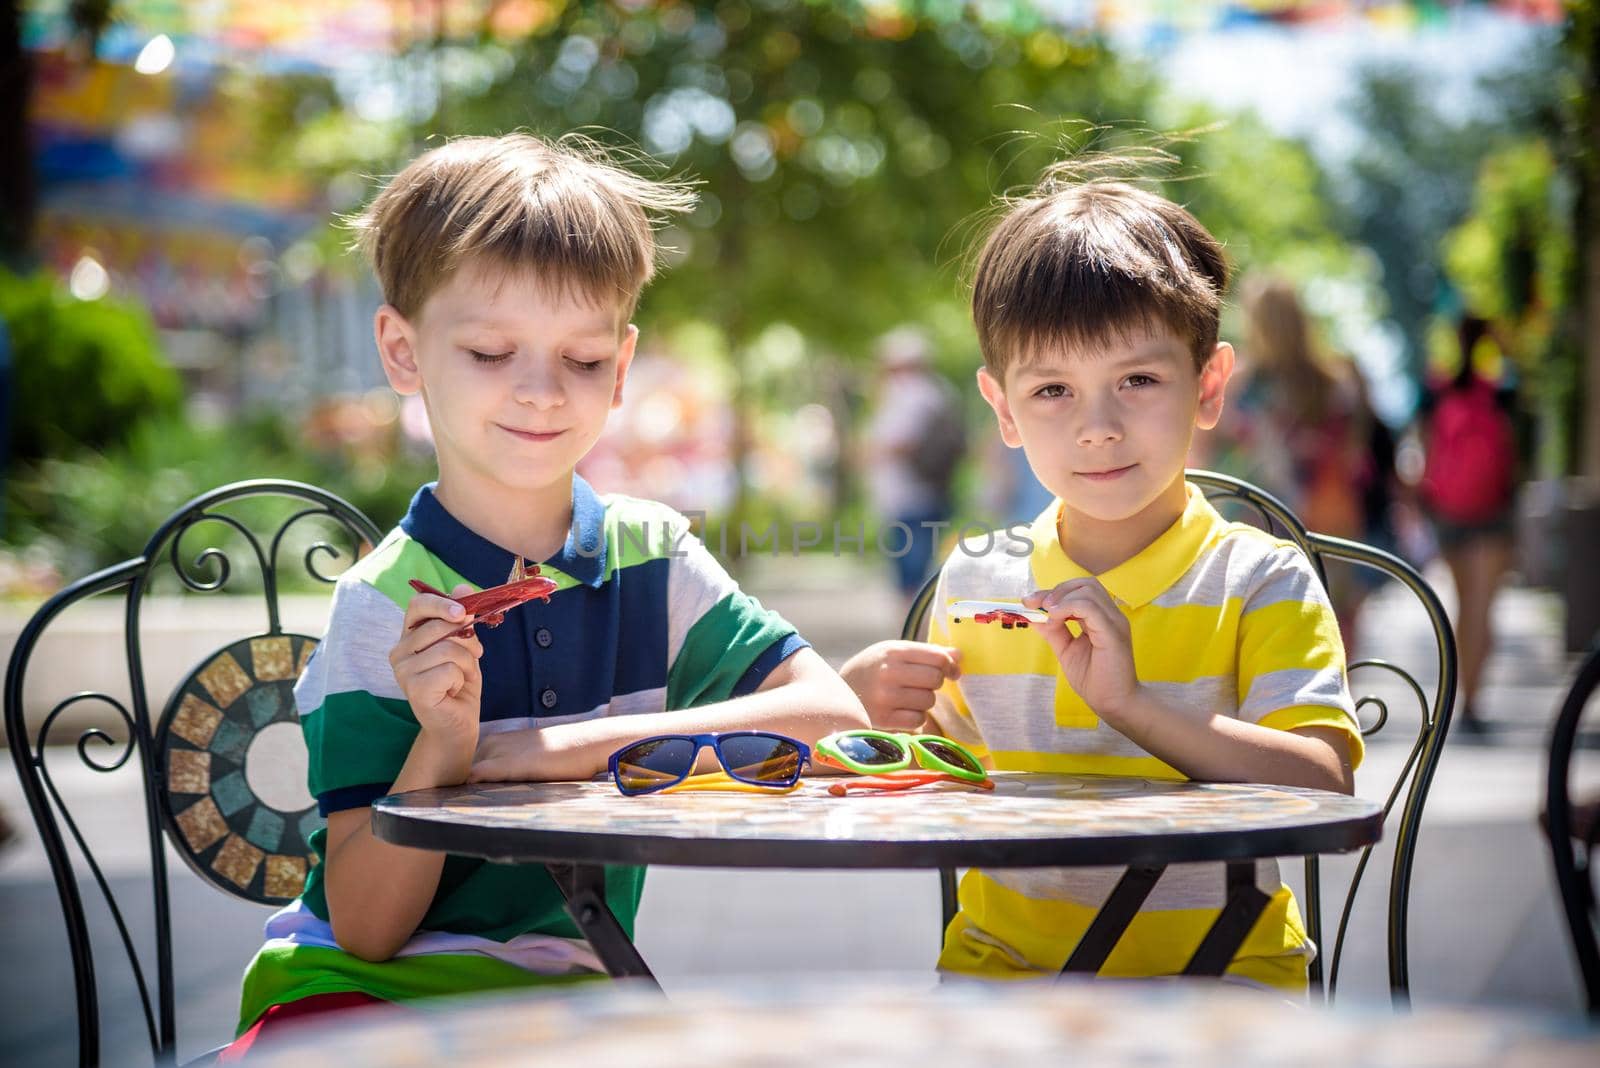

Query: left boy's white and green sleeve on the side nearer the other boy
[667,516,811,710]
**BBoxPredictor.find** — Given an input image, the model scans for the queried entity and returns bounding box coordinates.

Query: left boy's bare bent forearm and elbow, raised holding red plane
[326,732,475,961]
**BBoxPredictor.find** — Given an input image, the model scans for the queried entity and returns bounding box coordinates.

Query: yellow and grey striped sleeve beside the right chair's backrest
[1237,545,1365,767]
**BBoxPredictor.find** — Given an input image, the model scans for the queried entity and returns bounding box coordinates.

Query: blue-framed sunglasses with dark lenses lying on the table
[606,731,811,796]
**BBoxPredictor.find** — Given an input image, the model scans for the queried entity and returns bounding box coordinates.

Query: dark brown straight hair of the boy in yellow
[973,169,1227,382]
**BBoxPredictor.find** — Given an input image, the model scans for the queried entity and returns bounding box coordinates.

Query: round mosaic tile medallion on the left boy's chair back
[155,635,323,905]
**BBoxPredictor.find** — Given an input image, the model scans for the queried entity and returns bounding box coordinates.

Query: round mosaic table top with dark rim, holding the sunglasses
[373,772,1382,868]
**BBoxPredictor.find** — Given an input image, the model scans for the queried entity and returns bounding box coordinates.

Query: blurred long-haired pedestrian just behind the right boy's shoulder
[1214,277,1395,649]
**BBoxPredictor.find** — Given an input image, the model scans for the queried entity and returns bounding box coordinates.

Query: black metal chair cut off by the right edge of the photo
[1544,636,1600,1015]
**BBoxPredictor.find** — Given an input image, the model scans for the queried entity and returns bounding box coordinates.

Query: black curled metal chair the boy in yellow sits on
[901,470,1456,1006]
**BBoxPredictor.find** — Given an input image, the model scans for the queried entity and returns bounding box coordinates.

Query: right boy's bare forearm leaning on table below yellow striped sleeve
[1107,687,1350,793]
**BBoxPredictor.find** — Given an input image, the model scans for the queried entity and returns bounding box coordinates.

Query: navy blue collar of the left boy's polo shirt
[400,475,606,587]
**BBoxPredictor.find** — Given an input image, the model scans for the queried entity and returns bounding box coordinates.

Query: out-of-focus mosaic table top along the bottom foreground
[252,977,1600,1068]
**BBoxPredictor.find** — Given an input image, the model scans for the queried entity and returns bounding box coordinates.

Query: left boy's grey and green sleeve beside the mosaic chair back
[294,577,421,815]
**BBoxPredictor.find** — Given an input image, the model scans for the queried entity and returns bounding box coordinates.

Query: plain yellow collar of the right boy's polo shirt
[1029,483,1222,608]
